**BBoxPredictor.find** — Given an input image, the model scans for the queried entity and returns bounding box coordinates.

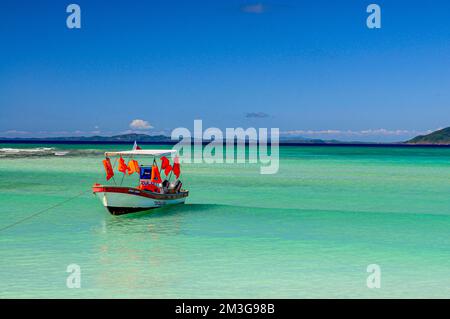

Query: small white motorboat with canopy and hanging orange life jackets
[92,147,189,215]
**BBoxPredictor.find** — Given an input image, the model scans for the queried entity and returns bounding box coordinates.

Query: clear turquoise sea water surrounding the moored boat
[0,145,450,298]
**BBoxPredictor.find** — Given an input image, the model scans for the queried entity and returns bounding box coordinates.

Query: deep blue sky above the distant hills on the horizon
[0,0,450,141]
